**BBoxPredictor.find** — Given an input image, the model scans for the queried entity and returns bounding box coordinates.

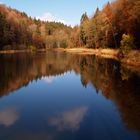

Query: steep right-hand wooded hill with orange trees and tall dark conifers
[77,0,140,48]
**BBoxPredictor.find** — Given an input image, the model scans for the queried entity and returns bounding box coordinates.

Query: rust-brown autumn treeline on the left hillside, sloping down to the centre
[0,4,71,50]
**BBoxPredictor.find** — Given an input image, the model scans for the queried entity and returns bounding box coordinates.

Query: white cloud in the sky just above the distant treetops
[36,12,68,24]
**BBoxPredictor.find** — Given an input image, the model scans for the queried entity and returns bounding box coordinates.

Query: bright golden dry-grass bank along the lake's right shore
[54,48,140,69]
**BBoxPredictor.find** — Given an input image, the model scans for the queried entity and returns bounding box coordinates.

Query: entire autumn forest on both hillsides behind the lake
[0,0,140,50]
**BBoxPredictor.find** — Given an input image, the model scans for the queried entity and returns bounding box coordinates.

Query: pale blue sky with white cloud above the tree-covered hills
[0,0,111,25]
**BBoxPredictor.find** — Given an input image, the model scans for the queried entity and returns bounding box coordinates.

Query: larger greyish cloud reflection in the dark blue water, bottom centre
[49,107,88,131]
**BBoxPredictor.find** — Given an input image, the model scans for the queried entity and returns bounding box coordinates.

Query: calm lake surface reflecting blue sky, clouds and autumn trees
[0,52,140,140]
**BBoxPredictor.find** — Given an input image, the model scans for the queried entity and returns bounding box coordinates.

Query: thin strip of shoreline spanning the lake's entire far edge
[0,48,140,68]
